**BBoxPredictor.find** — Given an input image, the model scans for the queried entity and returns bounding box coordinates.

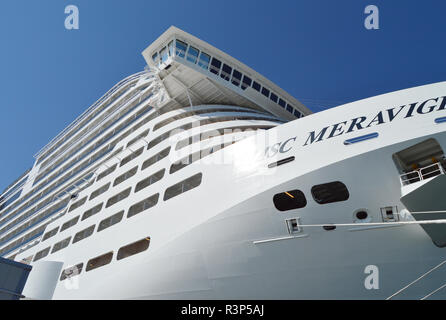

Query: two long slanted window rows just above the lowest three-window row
[34,169,202,261]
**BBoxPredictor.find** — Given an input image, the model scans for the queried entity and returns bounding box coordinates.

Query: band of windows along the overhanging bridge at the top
[152,40,304,118]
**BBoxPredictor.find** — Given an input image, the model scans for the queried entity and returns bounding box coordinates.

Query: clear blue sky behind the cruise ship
[0,0,446,190]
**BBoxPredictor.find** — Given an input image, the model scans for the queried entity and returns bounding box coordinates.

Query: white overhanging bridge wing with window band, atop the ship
[142,26,311,120]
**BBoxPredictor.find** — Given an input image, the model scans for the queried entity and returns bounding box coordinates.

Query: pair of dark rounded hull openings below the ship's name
[273,181,350,211]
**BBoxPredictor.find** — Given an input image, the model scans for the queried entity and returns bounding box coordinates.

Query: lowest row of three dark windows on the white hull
[60,237,150,281]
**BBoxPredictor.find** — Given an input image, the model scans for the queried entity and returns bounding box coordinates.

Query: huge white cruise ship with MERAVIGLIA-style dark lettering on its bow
[0,26,446,299]
